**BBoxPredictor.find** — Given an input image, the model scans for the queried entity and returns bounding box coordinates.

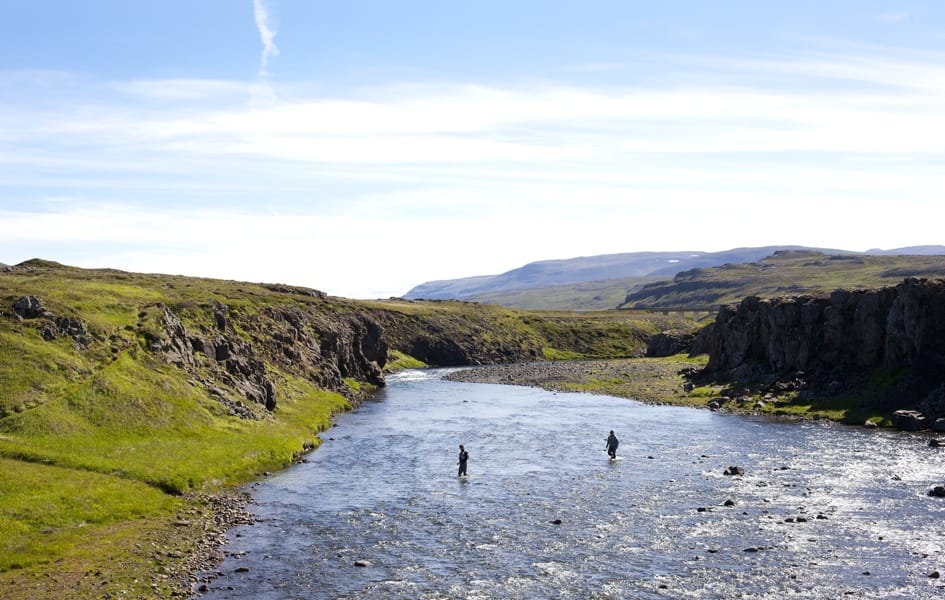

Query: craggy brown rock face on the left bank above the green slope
[145,303,387,418]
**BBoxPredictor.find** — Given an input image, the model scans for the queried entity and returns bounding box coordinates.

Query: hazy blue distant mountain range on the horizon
[404,246,945,310]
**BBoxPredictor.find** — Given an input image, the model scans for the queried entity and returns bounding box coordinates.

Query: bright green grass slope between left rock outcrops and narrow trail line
[0,357,347,493]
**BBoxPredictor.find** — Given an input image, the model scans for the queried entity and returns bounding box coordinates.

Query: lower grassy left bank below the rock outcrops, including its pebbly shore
[0,359,347,598]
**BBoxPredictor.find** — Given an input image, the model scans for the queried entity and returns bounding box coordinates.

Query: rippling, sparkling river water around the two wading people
[199,370,945,600]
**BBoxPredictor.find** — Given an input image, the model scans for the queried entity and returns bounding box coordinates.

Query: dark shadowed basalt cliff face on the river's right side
[697,279,945,416]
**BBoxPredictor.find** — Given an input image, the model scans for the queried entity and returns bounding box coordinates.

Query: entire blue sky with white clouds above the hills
[0,0,945,298]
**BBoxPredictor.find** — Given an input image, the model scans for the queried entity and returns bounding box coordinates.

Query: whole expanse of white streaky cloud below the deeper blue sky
[0,44,945,296]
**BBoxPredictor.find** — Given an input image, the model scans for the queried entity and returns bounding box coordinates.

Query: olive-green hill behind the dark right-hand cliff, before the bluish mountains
[620,251,945,309]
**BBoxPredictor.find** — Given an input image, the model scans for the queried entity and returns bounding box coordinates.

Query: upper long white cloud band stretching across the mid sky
[16,76,945,165]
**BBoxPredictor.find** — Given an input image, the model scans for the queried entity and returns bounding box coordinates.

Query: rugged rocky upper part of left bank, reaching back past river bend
[0,260,685,426]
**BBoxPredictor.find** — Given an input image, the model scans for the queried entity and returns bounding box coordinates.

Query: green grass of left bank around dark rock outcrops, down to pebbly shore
[0,261,349,599]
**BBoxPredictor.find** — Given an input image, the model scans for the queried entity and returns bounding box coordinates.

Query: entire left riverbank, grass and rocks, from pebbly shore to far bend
[0,260,691,598]
